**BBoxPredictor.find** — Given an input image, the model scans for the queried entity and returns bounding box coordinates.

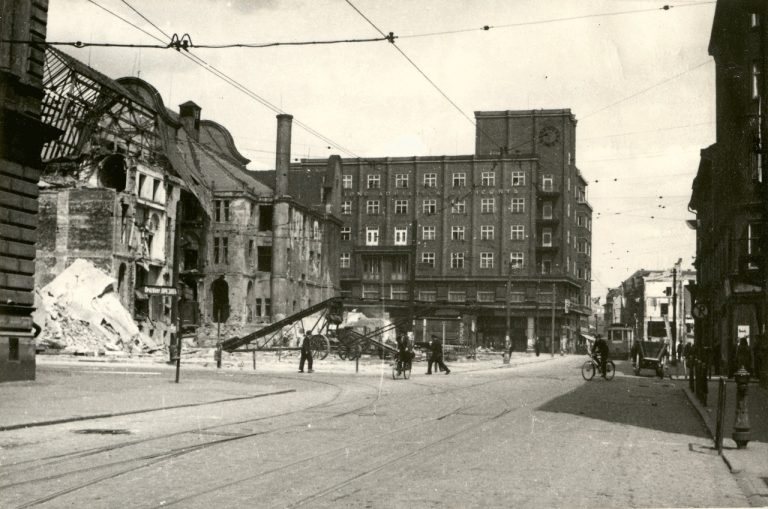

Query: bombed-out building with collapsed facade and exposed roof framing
[36,49,340,342]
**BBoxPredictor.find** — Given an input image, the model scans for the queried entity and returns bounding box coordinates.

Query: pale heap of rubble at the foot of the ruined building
[33,259,160,355]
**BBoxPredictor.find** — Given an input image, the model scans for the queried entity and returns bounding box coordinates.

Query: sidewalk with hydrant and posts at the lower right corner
[685,378,768,507]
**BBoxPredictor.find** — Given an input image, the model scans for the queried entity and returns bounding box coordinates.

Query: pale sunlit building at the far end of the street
[613,269,696,341]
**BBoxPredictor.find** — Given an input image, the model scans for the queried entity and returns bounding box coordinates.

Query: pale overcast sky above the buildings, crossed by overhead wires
[48,0,715,297]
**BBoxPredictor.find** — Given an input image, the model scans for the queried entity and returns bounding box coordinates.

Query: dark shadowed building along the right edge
[689,0,768,380]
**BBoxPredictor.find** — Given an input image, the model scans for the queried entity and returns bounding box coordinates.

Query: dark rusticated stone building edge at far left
[0,0,59,382]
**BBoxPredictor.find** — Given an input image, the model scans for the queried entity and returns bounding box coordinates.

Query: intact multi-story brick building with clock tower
[293,110,592,351]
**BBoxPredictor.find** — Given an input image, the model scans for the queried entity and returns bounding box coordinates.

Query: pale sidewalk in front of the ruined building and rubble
[0,349,560,432]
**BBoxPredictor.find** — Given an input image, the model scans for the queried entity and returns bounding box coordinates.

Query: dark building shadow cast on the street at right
[538,361,709,438]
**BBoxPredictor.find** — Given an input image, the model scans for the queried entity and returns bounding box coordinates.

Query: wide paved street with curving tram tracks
[0,356,748,507]
